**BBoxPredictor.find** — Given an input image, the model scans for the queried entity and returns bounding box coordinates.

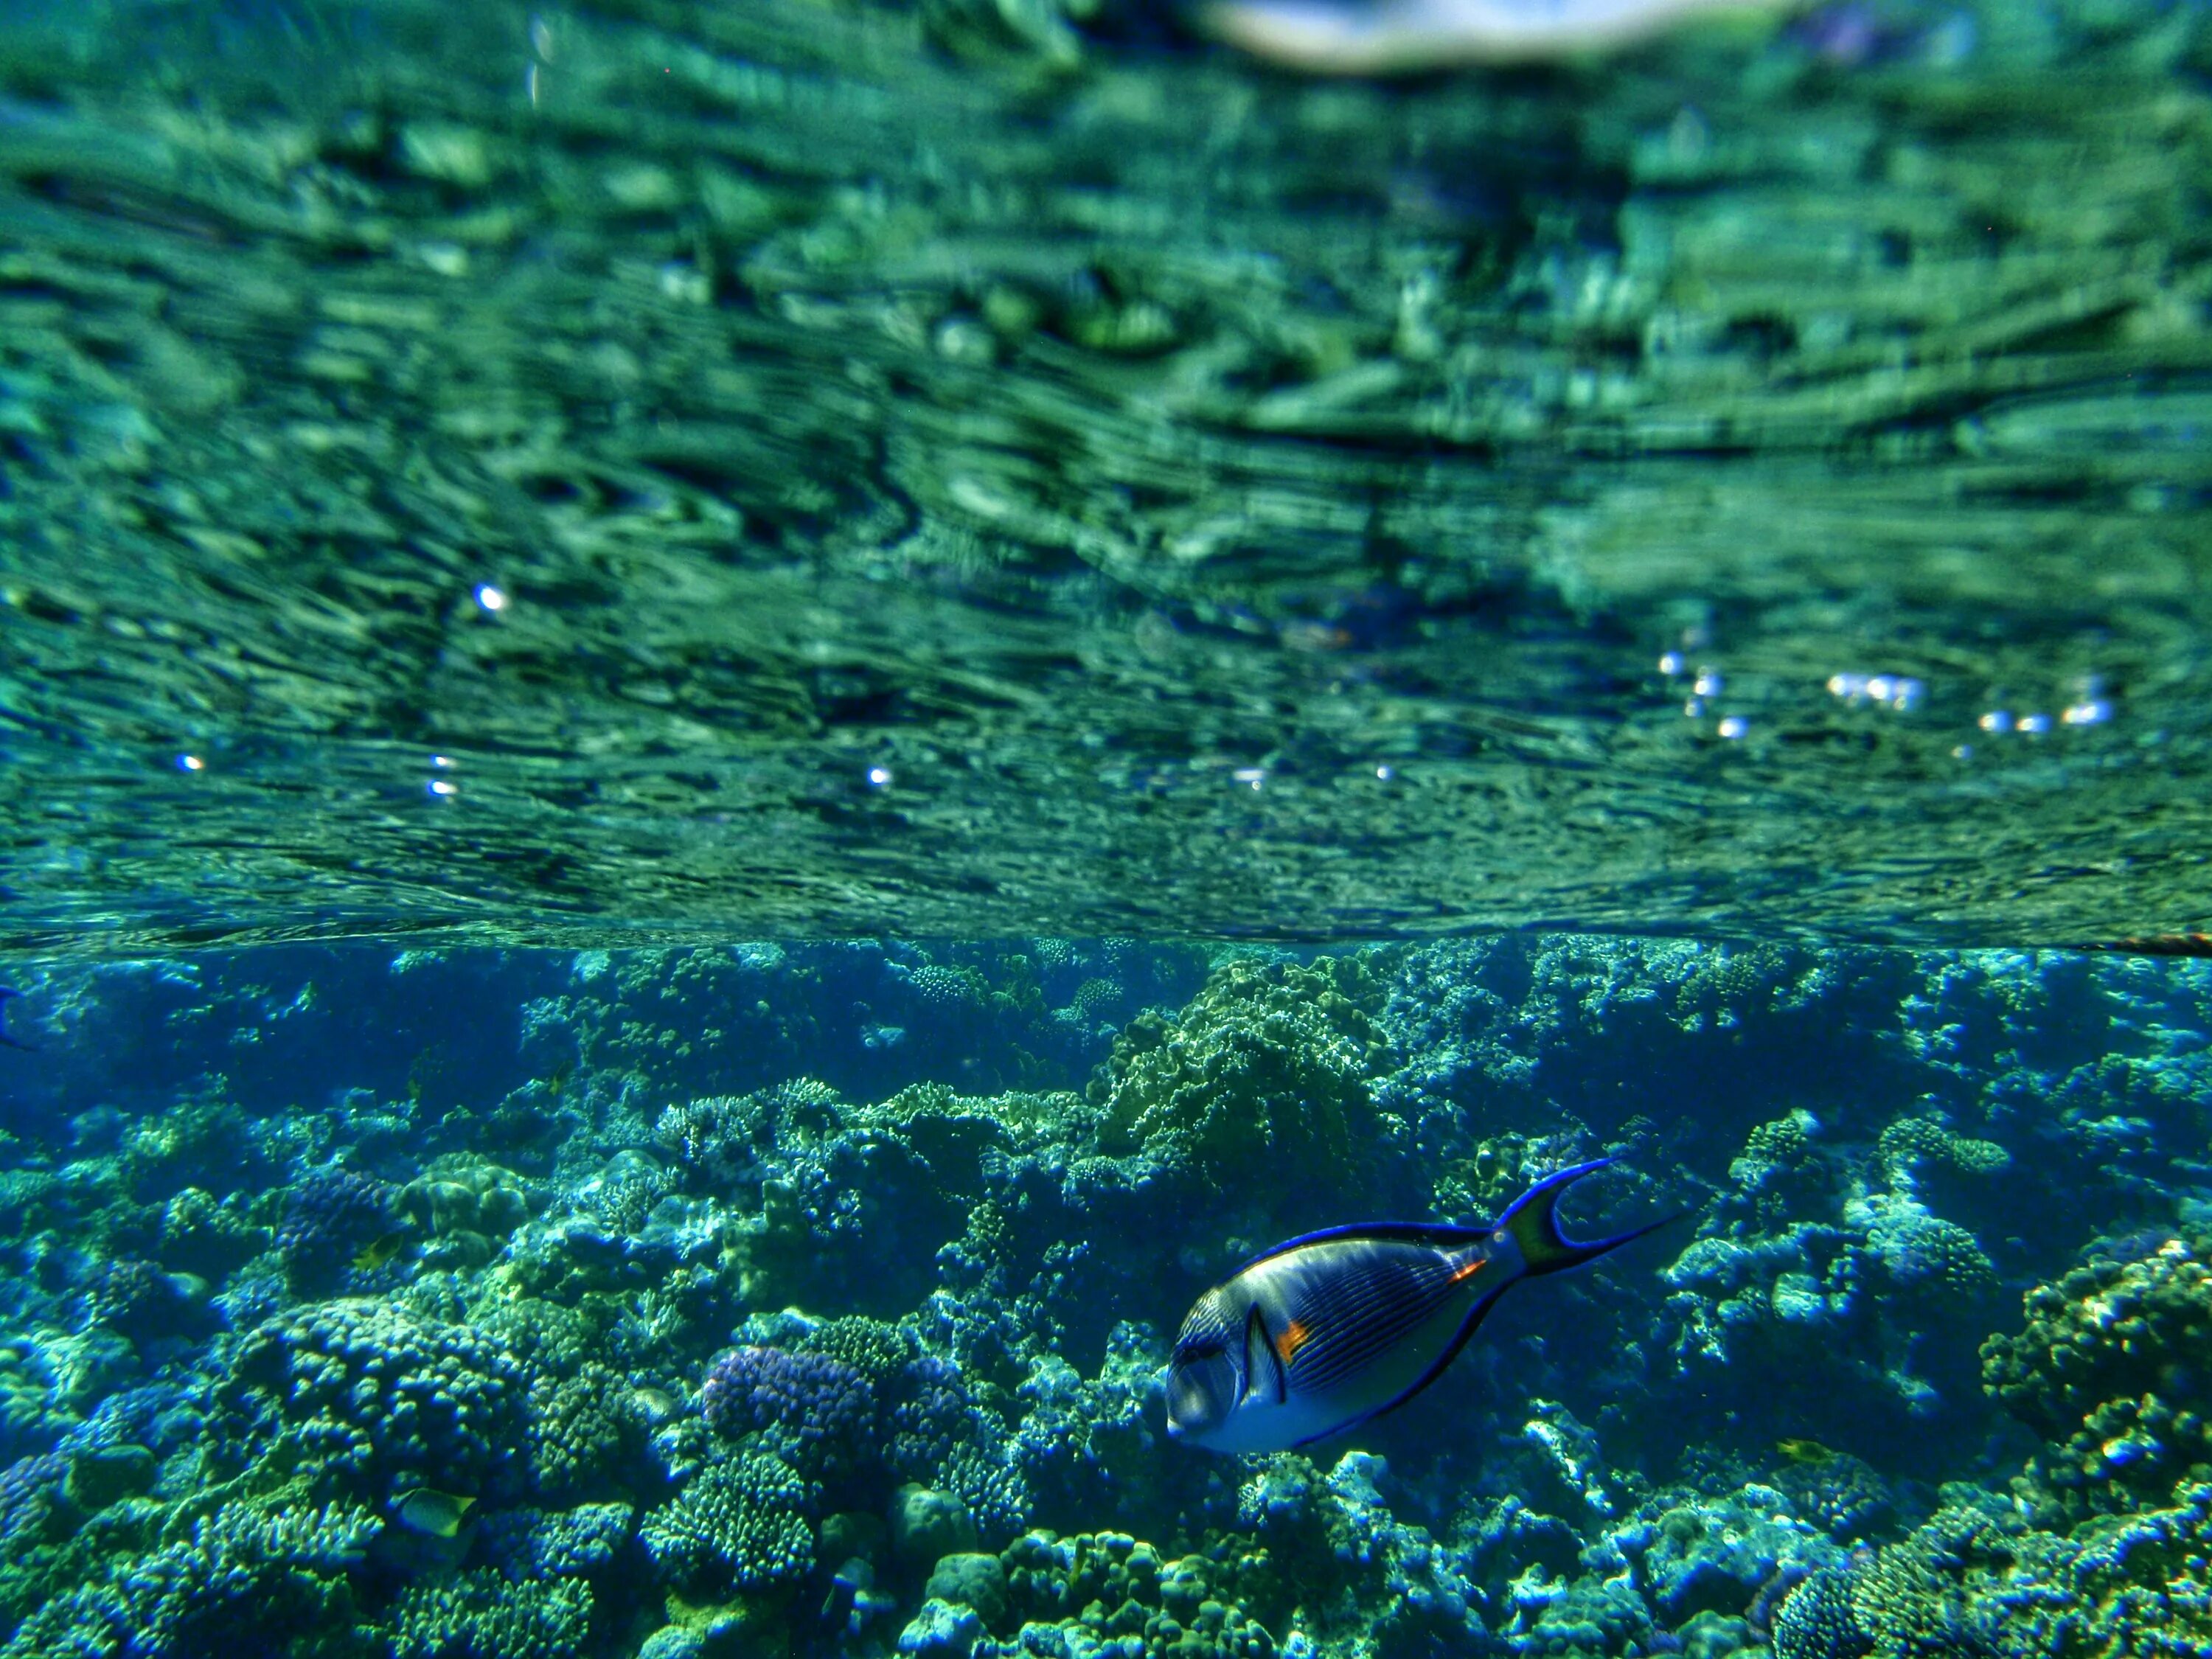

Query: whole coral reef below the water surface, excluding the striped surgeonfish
[0,936,2212,1659]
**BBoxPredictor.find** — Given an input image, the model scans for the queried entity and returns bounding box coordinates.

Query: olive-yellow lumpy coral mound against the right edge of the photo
[1982,1239,2212,1520]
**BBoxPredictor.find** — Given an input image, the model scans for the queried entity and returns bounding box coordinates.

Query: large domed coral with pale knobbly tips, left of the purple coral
[219,1298,526,1495]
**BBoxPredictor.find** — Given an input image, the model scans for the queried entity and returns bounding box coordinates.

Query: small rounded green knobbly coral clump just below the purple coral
[639,1451,814,1593]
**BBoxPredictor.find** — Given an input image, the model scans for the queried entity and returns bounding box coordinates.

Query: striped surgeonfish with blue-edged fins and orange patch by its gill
[1168,1159,1674,1451]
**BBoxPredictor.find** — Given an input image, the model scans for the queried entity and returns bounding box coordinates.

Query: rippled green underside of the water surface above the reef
[0,0,2212,949]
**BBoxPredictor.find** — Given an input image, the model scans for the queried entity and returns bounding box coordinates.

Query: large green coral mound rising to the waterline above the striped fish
[1102,956,1385,1181]
